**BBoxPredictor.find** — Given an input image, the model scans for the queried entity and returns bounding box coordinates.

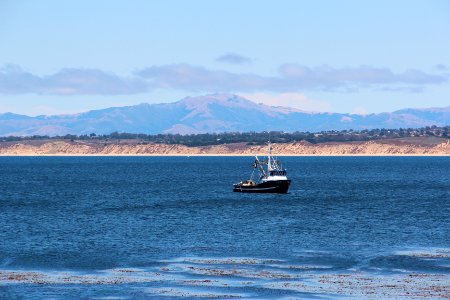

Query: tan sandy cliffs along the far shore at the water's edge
[0,139,450,156]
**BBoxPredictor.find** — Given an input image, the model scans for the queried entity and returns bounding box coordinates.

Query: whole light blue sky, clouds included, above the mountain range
[0,0,450,115]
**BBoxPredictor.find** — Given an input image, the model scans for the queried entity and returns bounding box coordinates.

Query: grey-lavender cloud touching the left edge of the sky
[0,65,149,95]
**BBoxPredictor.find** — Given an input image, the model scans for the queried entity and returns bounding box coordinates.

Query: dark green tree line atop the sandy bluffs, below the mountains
[0,126,450,147]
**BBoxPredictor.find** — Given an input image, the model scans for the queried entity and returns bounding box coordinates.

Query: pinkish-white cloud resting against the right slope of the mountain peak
[239,93,332,112]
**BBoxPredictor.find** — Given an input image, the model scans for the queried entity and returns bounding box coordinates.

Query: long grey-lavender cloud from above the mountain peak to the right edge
[136,64,447,93]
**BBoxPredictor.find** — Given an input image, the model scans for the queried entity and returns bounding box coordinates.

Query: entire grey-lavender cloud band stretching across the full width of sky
[0,64,448,95]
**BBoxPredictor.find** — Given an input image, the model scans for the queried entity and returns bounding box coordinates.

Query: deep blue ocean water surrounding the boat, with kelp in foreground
[0,157,450,299]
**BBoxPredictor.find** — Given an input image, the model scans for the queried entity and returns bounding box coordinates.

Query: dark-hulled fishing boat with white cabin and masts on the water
[233,143,291,194]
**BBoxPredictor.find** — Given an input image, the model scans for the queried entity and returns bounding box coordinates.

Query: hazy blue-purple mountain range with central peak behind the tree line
[0,94,450,136]
